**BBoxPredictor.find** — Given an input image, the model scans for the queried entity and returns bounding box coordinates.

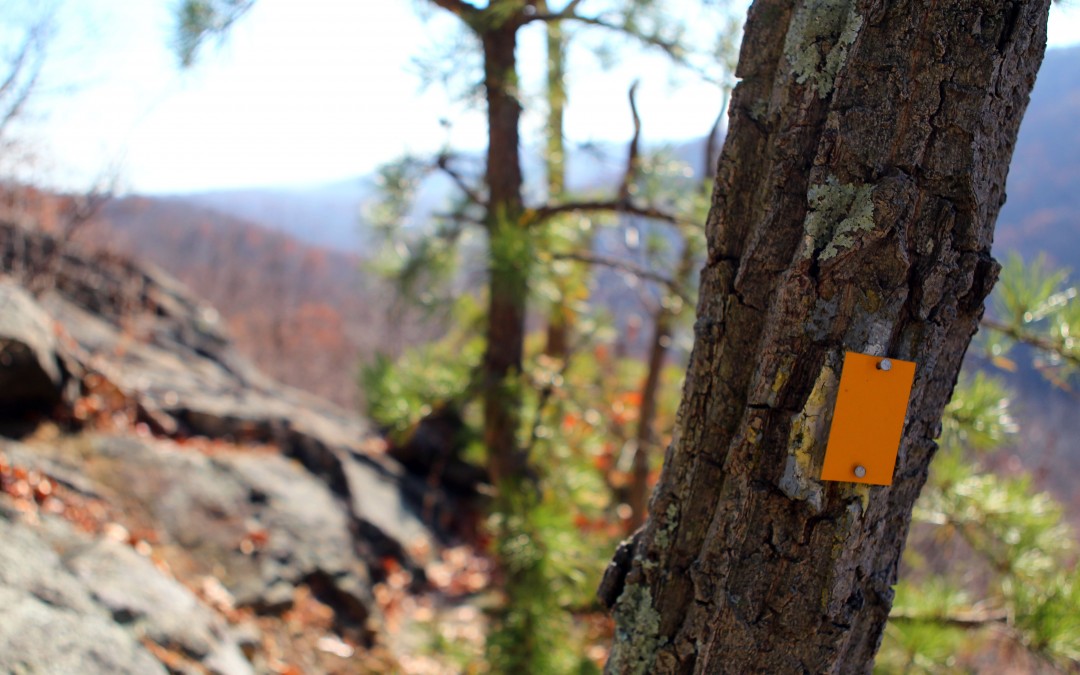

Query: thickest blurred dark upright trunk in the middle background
[480,21,531,484]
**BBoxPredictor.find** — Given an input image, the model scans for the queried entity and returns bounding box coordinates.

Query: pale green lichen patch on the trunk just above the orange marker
[804,176,874,260]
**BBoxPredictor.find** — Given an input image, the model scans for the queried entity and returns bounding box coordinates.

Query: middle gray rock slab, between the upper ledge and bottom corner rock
[82,436,374,621]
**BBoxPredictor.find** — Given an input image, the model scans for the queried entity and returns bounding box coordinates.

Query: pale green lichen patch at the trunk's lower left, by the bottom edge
[608,584,667,675]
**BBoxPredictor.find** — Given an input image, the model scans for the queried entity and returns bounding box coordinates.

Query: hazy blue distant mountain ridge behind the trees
[156,46,1080,270]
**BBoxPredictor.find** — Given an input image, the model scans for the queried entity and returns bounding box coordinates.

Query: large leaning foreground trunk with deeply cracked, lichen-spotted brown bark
[600,0,1049,673]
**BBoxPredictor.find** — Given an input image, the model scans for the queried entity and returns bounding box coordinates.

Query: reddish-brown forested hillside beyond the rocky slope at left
[78,192,435,409]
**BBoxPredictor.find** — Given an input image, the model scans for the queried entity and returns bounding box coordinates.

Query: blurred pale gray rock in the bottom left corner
[0,505,252,675]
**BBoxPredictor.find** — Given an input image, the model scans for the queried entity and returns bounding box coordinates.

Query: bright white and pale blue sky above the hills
[12,0,1080,193]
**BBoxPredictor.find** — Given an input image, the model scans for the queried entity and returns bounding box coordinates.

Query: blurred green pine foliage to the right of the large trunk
[877,256,1080,673]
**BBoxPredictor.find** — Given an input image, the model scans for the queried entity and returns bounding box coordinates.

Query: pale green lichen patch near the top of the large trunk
[784,0,863,98]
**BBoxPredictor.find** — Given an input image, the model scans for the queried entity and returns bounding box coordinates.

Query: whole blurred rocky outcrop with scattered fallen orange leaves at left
[0,222,477,673]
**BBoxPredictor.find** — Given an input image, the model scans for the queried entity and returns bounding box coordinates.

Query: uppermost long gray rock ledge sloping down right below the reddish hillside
[6,222,449,573]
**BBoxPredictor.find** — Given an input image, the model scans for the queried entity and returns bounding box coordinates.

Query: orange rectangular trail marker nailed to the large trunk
[821,352,915,485]
